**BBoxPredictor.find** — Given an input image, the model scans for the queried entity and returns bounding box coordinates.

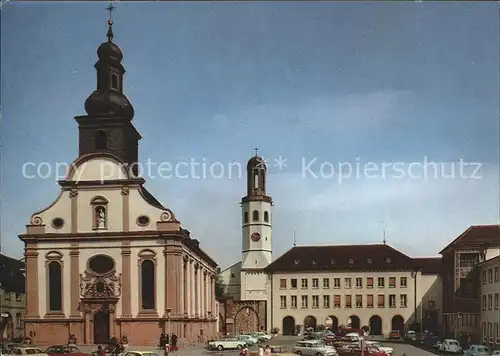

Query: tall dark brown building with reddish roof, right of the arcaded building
[440,225,500,341]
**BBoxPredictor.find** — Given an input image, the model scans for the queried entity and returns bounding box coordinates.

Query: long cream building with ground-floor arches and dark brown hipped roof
[266,244,441,335]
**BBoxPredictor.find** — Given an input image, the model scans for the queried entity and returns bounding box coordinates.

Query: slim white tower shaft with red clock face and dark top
[241,149,273,300]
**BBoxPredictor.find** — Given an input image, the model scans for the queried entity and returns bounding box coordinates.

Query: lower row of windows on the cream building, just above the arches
[280,294,408,309]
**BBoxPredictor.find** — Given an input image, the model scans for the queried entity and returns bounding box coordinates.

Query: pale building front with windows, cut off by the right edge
[479,256,500,348]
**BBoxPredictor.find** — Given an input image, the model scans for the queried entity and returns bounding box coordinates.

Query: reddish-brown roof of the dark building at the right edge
[439,225,500,255]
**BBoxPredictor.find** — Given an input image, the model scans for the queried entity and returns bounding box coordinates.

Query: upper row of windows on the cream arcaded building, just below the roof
[280,277,408,289]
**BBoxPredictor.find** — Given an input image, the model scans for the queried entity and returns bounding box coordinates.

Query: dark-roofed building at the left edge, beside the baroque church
[0,254,26,342]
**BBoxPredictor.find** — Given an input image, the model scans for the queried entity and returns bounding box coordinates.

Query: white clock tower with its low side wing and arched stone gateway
[219,154,273,333]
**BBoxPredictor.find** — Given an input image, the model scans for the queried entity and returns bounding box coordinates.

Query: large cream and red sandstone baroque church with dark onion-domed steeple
[19,18,218,346]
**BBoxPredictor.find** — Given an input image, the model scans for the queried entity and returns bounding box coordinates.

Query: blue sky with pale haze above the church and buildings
[1,2,499,266]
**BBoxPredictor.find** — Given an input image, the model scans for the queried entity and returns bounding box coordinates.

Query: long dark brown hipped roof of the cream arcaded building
[265,244,415,272]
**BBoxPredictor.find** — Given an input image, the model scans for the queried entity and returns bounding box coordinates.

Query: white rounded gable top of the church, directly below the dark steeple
[68,157,128,181]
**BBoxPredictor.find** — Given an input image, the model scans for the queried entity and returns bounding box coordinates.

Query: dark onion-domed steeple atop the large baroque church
[75,14,141,176]
